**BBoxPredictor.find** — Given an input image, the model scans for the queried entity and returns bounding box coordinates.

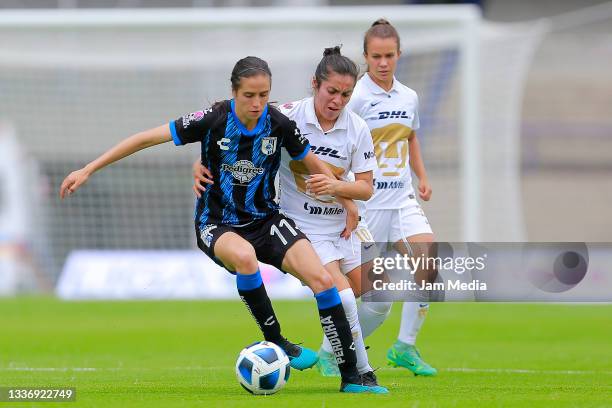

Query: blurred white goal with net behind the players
[0,6,539,284]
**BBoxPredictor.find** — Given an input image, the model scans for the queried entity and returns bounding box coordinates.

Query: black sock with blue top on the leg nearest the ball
[236,271,285,344]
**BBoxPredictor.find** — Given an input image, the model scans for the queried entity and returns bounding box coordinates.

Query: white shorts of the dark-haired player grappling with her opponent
[308,224,379,274]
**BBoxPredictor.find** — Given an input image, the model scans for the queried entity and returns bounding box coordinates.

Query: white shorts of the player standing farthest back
[366,200,433,242]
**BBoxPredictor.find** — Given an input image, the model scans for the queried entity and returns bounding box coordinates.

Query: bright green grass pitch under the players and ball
[0,298,612,408]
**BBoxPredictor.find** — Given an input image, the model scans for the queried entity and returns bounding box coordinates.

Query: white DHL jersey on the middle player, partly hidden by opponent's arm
[279,97,376,236]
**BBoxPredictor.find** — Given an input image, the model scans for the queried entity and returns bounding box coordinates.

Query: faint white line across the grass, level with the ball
[0,366,612,375]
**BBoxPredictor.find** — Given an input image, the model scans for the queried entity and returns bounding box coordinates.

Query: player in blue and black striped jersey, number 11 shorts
[60,57,378,392]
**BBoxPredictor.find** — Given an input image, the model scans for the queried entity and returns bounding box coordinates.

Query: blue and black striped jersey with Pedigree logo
[170,100,309,226]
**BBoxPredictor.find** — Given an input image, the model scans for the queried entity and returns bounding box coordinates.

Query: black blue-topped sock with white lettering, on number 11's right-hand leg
[315,287,359,383]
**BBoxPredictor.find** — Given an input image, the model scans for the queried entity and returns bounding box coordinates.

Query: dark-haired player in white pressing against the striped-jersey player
[194,47,388,394]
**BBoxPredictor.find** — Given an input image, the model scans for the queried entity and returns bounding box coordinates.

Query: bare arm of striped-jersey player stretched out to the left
[60,124,172,199]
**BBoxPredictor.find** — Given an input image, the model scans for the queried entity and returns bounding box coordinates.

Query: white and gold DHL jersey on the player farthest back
[348,73,419,210]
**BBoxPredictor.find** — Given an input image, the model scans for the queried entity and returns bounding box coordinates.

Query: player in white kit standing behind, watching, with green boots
[348,19,436,376]
